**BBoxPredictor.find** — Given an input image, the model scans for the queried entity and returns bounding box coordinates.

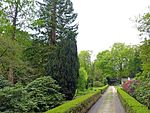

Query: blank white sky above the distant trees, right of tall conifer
[71,0,150,58]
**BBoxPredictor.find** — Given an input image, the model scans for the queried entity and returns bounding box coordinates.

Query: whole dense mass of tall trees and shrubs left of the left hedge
[0,0,79,112]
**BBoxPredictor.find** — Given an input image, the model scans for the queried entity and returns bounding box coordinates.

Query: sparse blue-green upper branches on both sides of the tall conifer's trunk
[32,0,78,42]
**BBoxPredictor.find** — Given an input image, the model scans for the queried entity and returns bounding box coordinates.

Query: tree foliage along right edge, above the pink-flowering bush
[136,9,150,78]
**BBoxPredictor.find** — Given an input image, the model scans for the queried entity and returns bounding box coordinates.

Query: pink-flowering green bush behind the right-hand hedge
[122,78,150,109]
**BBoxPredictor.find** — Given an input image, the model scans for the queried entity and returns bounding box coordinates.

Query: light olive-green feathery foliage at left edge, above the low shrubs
[0,37,34,84]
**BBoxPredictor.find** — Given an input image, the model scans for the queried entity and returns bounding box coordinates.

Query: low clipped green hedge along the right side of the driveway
[117,88,150,113]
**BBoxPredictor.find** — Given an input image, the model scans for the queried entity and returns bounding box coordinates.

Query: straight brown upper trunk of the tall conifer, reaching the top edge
[49,0,56,45]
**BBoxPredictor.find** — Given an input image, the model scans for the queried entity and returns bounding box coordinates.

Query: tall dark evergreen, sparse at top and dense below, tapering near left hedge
[33,0,79,99]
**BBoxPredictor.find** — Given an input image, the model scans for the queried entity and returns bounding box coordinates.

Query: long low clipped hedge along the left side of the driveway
[46,86,108,113]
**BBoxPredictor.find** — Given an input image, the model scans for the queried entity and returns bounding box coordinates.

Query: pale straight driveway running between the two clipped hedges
[87,86,125,113]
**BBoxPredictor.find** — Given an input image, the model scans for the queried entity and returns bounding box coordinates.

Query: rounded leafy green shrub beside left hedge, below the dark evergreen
[25,77,63,112]
